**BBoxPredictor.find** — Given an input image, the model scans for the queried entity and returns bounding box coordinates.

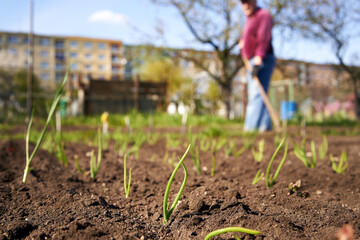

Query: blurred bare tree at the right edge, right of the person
[281,0,360,119]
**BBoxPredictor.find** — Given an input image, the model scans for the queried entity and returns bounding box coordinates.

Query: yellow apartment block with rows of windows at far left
[0,32,123,89]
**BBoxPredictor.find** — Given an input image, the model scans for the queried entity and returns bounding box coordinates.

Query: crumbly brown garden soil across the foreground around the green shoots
[0,126,360,240]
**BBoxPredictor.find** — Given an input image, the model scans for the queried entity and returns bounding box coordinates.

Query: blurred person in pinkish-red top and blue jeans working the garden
[239,0,276,132]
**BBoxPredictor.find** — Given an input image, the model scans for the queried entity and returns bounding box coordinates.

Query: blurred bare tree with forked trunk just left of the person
[151,0,244,115]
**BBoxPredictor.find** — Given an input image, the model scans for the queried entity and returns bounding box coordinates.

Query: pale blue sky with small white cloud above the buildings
[0,0,360,64]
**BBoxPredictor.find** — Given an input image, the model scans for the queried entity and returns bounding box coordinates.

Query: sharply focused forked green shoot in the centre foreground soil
[163,145,191,225]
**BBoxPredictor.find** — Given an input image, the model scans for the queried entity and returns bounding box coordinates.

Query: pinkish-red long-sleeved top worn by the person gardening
[241,8,273,59]
